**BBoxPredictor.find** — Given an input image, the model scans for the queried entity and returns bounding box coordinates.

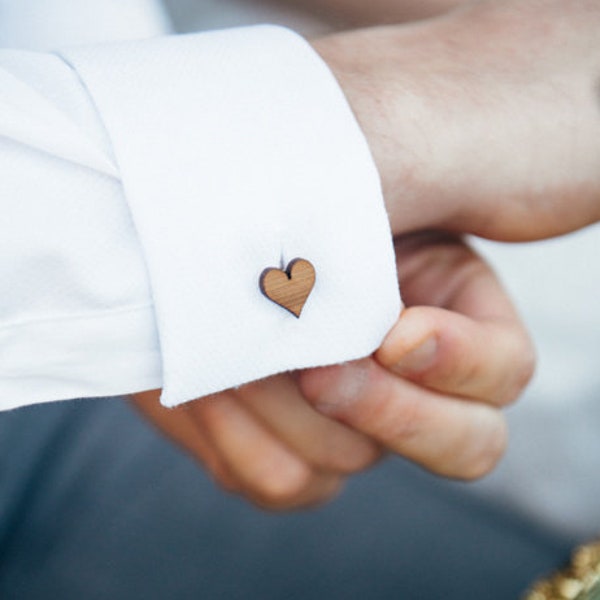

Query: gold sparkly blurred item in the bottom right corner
[523,541,600,600]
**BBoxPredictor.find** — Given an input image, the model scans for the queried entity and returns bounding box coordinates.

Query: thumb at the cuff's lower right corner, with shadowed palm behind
[375,233,535,405]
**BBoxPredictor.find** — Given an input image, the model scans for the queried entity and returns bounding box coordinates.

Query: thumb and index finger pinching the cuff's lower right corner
[300,232,534,479]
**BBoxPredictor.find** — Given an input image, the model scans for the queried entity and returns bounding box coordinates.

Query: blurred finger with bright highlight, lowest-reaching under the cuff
[191,392,341,510]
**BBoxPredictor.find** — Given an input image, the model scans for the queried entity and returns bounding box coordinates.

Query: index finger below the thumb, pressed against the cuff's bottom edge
[300,359,506,479]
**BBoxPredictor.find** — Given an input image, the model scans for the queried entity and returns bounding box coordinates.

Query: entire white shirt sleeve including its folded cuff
[0,26,400,407]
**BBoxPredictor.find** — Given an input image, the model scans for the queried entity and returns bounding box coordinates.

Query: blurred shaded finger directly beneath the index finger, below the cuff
[237,375,381,474]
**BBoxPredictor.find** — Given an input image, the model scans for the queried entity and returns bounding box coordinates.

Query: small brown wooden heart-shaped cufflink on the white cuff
[260,258,316,317]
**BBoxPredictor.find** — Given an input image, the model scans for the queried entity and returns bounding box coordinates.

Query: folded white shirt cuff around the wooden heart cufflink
[61,26,400,406]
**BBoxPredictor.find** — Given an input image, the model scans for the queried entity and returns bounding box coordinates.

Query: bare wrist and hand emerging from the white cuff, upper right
[314,0,600,241]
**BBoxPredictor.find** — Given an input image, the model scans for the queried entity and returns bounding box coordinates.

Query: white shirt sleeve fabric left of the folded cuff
[0,50,161,408]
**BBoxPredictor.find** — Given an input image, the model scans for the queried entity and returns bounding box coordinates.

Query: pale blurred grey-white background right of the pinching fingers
[475,230,600,538]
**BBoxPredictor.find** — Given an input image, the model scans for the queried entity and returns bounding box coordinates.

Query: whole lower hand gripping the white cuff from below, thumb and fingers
[134,227,534,509]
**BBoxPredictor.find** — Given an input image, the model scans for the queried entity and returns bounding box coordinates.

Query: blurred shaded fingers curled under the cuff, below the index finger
[132,374,381,510]
